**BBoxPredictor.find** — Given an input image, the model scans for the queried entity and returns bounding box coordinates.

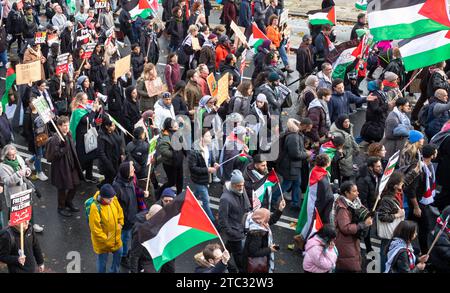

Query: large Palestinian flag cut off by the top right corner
[367,0,450,41]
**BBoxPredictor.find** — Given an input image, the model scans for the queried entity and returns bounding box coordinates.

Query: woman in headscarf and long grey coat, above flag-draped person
[330,115,359,181]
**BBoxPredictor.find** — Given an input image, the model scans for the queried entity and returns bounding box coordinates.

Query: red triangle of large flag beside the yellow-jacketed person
[178,188,218,236]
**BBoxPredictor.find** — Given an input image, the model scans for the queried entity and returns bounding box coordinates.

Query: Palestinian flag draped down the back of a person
[296,167,328,240]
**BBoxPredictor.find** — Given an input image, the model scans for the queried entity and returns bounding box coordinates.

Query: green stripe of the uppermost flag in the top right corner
[370,19,449,41]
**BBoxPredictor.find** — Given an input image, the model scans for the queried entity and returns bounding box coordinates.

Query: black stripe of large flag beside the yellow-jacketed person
[137,192,186,243]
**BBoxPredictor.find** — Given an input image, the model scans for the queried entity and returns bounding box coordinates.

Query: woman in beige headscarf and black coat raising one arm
[242,200,286,273]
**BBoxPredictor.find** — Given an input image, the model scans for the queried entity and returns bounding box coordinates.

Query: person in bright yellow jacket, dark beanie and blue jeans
[89,184,124,273]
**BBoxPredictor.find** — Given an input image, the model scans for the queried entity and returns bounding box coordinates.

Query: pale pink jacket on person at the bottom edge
[303,235,338,273]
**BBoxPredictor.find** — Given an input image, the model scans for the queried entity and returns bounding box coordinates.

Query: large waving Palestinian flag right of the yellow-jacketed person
[137,187,220,271]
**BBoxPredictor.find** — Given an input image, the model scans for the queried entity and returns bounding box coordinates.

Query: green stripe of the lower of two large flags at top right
[402,44,450,71]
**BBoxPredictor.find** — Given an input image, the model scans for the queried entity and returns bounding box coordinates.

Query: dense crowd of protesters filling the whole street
[0,0,450,273]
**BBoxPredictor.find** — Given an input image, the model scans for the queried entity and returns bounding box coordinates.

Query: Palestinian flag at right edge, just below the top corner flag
[399,30,450,71]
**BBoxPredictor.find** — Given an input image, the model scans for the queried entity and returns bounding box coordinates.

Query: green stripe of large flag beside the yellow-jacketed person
[153,229,218,271]
